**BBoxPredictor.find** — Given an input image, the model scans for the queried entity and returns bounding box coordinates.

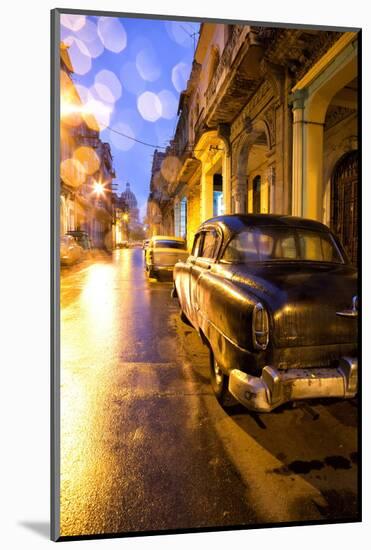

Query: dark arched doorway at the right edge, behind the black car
[331,151,358,263]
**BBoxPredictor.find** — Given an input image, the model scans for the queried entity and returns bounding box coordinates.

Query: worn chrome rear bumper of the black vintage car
[229,357,358,412]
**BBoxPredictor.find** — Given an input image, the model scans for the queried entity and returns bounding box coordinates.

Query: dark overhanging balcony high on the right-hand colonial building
[204,25,263,128]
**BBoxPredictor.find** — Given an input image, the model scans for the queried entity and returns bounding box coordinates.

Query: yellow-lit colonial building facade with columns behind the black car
[147,23,358,260]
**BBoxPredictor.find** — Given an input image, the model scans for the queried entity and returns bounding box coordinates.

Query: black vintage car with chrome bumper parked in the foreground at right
[173,214,358,412]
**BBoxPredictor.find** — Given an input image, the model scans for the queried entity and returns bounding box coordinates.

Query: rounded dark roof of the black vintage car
[200,214,330,233]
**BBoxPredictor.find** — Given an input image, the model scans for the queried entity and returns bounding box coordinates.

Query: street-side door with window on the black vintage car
[190,227,221,327]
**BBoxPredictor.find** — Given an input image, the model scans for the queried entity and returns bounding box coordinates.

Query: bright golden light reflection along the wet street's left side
[60,249,153,535]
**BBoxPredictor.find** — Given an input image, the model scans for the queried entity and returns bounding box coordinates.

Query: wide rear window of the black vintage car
[223,227,344,263]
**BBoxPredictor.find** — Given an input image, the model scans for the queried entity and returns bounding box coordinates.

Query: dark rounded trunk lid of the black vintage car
[234,262,357,347]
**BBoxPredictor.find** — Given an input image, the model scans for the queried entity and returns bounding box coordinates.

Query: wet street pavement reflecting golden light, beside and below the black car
[61,248,358,536]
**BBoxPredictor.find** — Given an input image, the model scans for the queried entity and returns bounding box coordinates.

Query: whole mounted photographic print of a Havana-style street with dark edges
[52,9,361,540]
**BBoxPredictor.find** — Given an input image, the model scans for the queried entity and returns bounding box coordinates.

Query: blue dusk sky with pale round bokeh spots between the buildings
[61,15,199,219]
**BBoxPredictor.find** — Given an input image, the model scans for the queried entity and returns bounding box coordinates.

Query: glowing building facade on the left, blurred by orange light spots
[60,43,115,249]
